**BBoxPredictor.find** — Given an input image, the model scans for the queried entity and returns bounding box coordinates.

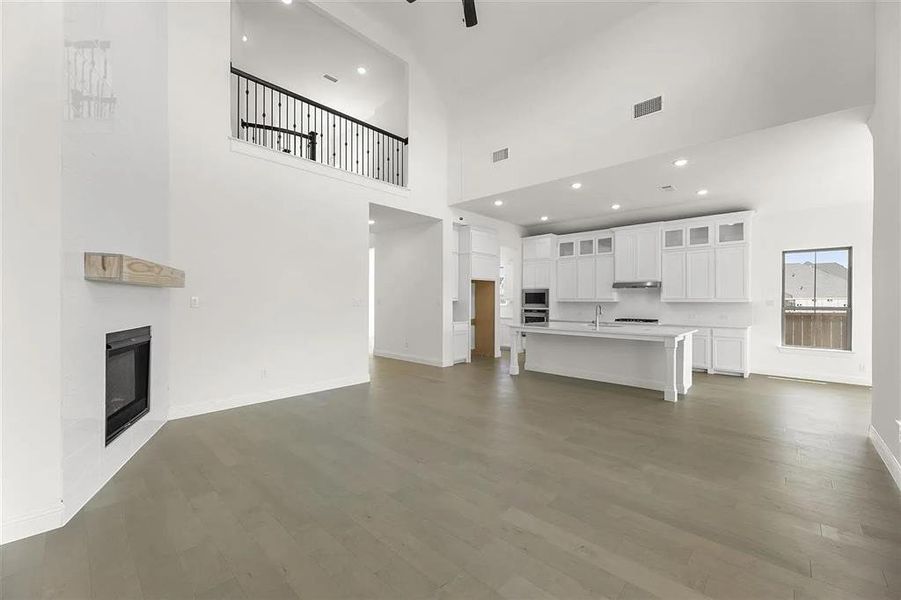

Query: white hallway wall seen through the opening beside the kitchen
[373,221,444,366]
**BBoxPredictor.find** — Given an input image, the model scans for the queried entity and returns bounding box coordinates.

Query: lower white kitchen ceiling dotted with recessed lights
[454,109,873,233]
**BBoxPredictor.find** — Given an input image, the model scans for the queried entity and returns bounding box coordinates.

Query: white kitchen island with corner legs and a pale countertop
[510,322,696,402]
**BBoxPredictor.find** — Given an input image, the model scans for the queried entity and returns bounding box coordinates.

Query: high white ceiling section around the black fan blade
[355,0,648,94]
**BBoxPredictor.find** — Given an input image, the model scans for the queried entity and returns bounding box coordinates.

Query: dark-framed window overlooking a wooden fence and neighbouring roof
[782,248,851,350]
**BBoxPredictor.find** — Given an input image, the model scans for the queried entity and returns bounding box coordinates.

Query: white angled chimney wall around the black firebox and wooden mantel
[61,2,174,519]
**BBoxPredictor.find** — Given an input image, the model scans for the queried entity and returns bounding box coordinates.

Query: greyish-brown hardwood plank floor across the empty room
[0,359,901,600]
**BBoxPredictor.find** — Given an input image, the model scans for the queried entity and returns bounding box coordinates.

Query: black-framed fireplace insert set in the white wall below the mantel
[106,327,150,445]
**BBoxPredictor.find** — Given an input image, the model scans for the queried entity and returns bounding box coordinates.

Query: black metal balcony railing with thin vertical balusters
[231,66,409,186]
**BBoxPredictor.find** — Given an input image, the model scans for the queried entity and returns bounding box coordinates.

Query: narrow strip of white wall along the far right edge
[870,2,901,487]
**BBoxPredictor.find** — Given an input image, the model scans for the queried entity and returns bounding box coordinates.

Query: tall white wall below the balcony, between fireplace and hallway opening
[169,3,374,417]
